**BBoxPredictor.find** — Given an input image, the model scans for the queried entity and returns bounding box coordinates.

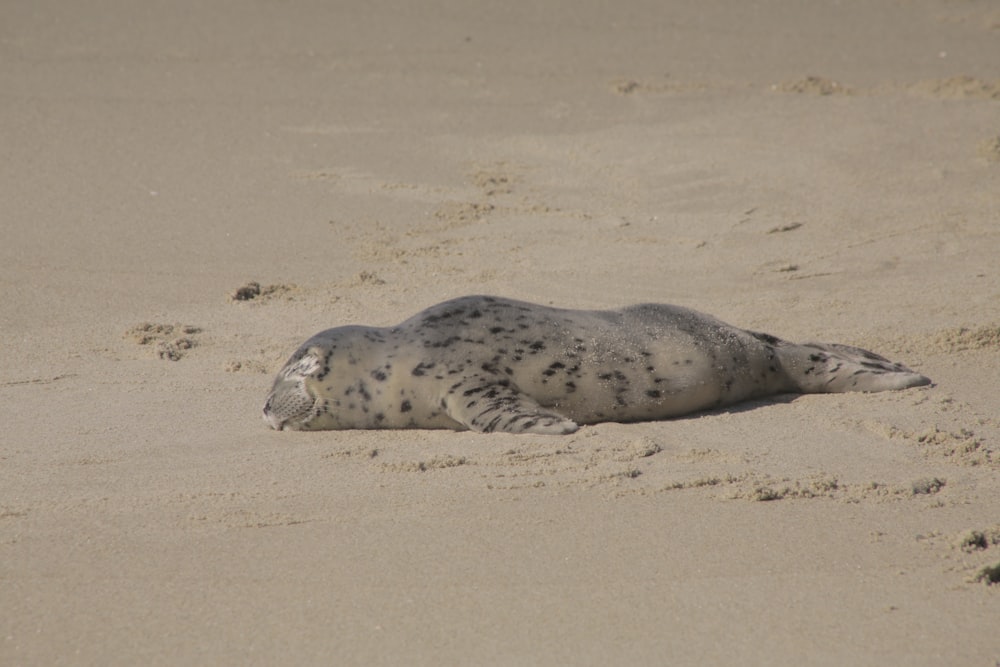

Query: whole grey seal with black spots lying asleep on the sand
[264,296,930,435]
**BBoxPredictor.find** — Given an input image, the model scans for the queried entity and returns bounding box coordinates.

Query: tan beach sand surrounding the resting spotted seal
[0,0,1000,666]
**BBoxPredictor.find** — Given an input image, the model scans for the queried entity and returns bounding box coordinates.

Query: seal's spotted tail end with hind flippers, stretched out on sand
[777,341,931,394]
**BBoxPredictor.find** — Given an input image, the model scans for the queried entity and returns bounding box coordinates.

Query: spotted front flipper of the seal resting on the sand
[442,375,579,435]
